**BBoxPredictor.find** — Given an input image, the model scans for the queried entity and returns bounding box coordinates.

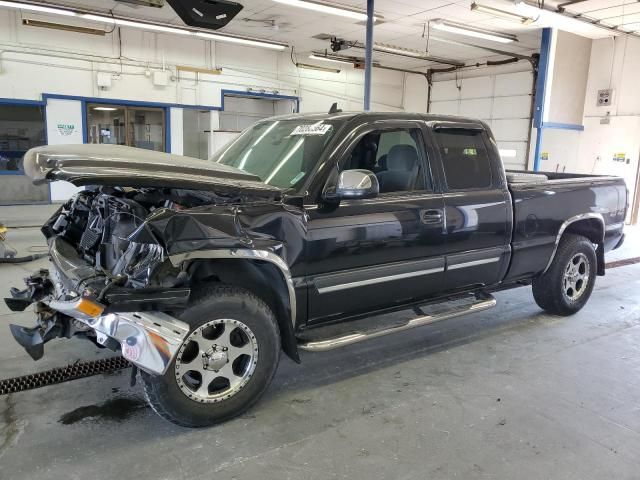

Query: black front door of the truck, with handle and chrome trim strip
[305,122,445,323]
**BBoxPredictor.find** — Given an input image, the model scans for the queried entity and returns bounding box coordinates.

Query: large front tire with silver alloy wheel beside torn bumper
[141,285,281,427]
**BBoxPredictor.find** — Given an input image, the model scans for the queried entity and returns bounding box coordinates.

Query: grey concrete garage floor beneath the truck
[0,215,640,480]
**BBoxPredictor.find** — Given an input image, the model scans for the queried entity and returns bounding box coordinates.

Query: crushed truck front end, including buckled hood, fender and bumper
[6,145,301,374]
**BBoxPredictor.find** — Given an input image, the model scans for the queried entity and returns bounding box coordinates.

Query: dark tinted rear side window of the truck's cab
[434,130,492,190]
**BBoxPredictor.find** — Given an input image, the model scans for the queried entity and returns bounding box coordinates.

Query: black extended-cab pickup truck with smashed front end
[6,113,628,426]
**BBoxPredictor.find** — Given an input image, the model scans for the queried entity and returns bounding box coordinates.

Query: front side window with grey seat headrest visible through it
[343,128,430,193]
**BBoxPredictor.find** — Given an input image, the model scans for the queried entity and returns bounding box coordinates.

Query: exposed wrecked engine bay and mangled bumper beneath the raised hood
[5,189,200,374]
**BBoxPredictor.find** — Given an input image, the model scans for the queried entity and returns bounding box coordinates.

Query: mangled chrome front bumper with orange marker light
[6,238,190,375]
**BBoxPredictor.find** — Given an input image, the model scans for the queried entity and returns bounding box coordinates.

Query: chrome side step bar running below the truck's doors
[298,295,496,352]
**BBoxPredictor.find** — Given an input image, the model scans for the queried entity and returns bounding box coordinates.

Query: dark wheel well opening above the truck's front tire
[188,259,300,363]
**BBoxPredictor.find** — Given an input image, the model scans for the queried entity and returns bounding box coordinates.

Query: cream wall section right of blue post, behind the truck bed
[541,32,640,222]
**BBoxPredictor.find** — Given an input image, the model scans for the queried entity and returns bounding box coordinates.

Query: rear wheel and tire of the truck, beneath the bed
[533,234,597,316]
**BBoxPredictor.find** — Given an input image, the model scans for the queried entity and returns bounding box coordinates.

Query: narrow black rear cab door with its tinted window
[432,122,513,290]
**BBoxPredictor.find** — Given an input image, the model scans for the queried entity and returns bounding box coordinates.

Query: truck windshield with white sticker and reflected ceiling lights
[211,118,338,189]
